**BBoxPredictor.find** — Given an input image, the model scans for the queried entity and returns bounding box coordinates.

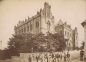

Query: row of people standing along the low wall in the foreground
[28,52,70,62]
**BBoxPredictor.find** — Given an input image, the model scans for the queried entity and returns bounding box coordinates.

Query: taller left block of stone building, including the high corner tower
[14,2,54,34]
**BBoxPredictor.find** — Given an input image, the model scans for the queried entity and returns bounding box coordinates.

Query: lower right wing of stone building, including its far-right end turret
[55,20,78,49]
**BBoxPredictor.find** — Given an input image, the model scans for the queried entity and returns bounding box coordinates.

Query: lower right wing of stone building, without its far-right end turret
[55,20,73,50]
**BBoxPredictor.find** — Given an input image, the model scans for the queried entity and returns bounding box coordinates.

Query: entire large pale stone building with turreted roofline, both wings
[14,2,78,48]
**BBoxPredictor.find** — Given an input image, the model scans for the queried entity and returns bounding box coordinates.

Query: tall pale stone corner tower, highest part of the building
[41,2,54,33]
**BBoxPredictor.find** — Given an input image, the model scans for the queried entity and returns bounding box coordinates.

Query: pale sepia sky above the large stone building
[0,0,86,48]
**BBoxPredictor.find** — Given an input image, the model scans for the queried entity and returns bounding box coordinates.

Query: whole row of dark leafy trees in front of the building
[5,32,65,56]
